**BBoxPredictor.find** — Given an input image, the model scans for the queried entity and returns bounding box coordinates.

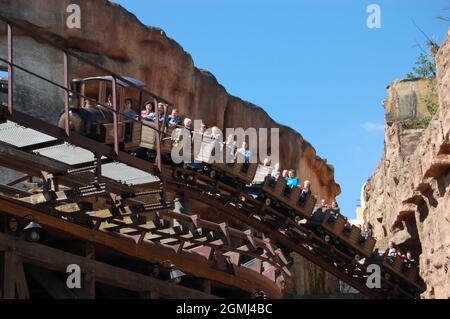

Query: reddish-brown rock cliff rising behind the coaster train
[0,0,340,293]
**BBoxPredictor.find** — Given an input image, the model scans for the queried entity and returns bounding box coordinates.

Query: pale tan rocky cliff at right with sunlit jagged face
[364,32,450,298]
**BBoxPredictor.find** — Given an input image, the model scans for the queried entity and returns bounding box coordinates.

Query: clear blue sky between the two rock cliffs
[114,0,450,217]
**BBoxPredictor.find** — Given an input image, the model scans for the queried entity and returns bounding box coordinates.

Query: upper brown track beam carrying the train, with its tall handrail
[0,16,422,298]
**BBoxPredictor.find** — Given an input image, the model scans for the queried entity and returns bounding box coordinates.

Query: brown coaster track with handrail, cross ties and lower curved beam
[0,16,424,298]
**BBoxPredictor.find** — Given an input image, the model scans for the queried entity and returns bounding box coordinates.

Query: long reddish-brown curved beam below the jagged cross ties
[0,195,283,298]
